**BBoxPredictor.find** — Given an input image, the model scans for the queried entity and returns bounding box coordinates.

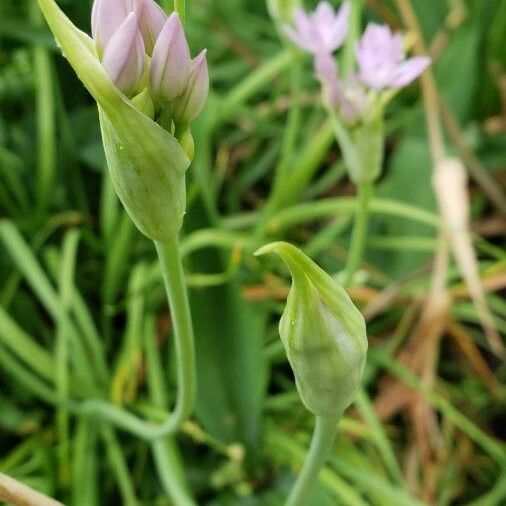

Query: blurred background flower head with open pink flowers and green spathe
[284,2,431,184]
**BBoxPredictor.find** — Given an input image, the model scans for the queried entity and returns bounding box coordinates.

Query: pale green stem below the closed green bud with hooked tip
[285,416,339,506]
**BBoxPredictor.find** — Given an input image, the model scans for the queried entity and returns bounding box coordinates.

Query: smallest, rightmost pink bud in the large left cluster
[173,49,209,125]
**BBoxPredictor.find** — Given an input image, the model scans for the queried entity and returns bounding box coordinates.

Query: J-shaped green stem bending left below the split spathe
[77,237,197,440]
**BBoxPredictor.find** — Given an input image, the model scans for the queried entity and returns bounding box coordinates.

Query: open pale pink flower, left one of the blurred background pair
[284,2,350,55]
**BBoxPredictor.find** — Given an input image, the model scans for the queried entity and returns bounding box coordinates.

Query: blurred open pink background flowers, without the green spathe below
[285,1,431,122]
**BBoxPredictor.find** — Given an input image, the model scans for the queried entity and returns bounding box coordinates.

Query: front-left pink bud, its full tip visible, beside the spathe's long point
[102,12,145,95]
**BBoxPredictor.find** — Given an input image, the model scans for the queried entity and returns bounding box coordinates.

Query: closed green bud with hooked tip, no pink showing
[256,242,367,417]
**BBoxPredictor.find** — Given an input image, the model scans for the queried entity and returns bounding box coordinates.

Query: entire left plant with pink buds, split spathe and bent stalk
[38,0,209,446]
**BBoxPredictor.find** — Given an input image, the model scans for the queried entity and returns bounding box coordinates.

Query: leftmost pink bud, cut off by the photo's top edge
[91,0,133,53]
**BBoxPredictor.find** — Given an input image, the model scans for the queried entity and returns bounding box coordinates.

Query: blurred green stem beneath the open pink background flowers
[344,182,374,288]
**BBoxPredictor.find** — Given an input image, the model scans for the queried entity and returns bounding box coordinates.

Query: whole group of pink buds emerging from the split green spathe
[91,0,209,128]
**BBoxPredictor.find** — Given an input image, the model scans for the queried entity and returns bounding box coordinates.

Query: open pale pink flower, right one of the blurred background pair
[357,23,431,90]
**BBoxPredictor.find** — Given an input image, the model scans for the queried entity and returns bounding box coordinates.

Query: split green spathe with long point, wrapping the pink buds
[38,0,190,242]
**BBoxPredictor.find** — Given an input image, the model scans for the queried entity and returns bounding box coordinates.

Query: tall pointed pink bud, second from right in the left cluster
[150,13,191,104]
